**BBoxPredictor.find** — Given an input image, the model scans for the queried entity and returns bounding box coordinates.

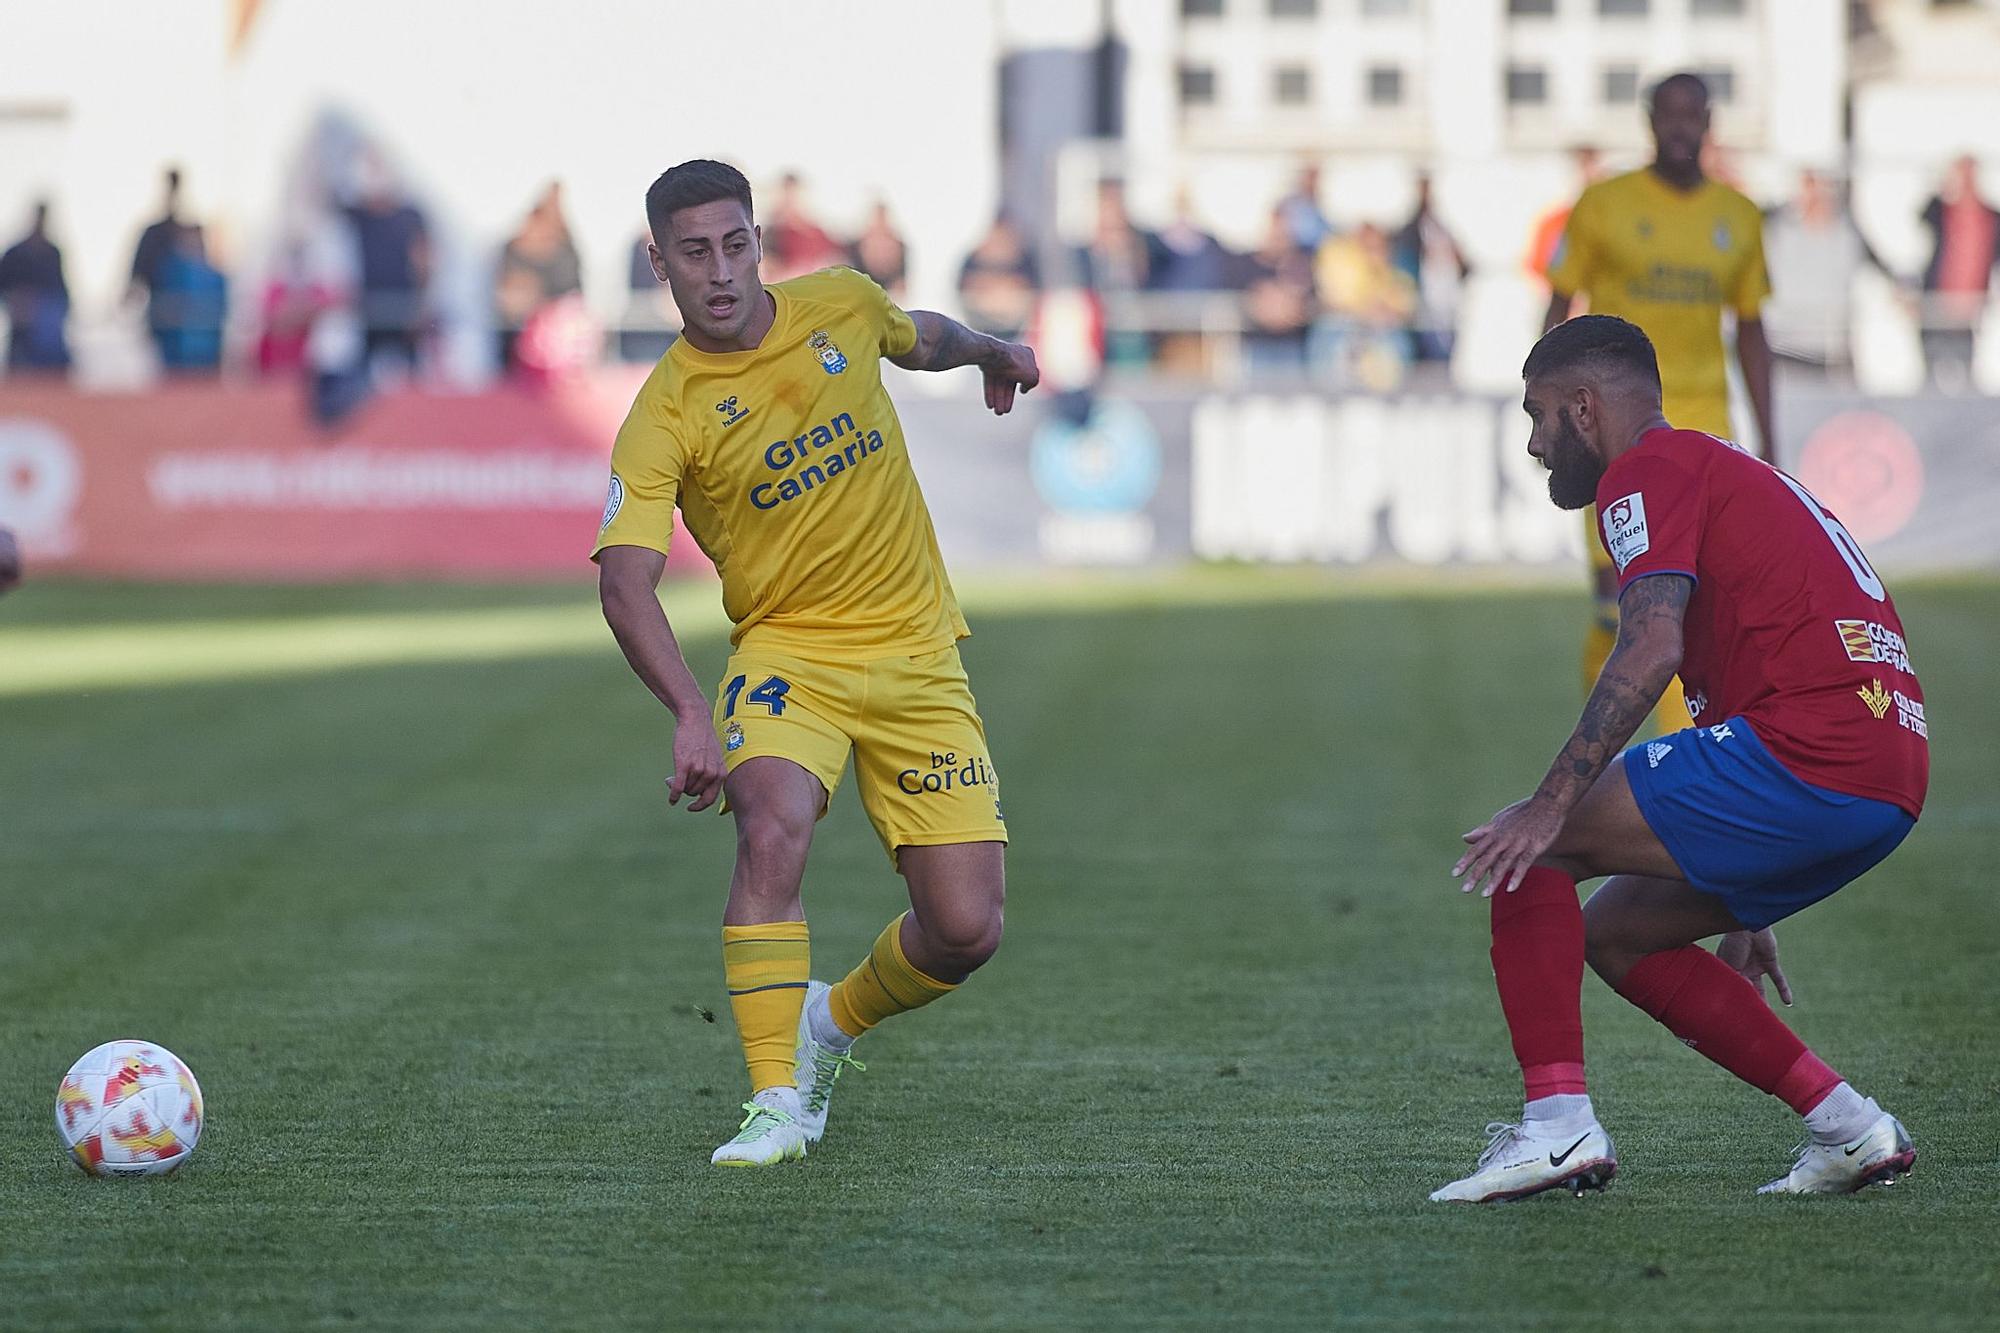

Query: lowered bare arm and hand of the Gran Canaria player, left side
[598,546,726,811]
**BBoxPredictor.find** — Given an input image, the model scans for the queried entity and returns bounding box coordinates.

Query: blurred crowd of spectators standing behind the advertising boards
[0,150,2000,396]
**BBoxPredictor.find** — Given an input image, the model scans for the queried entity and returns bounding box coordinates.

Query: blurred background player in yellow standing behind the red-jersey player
[1542,74,1776,731]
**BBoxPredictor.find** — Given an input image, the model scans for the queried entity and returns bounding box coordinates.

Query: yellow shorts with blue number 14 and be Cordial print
[716,646,1006,861]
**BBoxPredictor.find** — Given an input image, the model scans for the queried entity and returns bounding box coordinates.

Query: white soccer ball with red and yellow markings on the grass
[56,1041,202,1175]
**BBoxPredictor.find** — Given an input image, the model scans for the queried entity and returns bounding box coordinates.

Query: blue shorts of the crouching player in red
[1624,717,1916,931]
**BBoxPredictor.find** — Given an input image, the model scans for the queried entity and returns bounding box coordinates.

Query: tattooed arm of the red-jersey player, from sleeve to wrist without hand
[1536,574,1694,811]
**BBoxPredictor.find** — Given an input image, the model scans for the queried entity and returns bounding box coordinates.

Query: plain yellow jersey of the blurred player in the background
[1548,168,1770,438]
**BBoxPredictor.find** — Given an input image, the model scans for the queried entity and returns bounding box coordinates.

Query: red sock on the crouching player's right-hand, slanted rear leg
[1618,945,1840,1115]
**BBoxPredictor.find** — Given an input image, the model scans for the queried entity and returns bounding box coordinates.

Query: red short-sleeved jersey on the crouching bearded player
[1598,428,1930,819]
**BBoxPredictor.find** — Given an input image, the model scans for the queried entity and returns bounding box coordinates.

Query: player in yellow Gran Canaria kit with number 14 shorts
[592,160,1040,1167]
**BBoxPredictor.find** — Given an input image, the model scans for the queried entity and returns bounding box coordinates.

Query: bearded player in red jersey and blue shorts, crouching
[1432,314,1930,1203]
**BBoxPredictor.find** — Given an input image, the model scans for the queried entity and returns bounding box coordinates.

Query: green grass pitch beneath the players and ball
[0,572,2000,1331]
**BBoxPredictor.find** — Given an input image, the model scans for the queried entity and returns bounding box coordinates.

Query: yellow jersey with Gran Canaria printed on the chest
[590,268,968,660]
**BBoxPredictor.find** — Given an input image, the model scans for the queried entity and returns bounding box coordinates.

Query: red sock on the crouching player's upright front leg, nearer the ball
[1492,867,1588,1101]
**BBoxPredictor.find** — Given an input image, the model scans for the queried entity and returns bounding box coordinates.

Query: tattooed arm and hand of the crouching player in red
[1452,574,1694,897]
